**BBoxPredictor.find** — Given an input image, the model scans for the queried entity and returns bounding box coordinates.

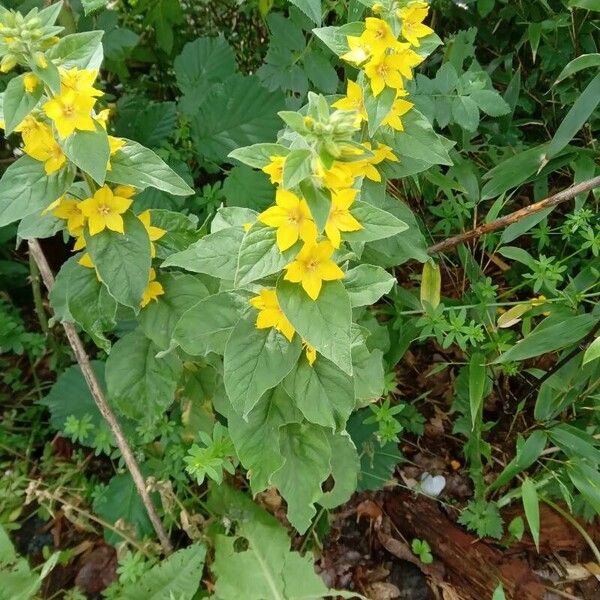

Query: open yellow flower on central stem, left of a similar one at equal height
[258,190,317,252]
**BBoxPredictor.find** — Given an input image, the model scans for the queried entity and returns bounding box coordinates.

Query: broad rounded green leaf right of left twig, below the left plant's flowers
[105,329,182,423]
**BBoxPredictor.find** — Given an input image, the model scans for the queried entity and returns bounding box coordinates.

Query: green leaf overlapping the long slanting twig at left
[49,255,117,351]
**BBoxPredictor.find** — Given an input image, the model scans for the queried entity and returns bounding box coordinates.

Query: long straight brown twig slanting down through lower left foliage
[29,239,173,554]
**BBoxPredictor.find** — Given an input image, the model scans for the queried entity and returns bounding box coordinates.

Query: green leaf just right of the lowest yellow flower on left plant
[139,273,209,350]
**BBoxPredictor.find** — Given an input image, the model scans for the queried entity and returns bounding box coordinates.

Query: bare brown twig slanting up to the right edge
[427,177,600,255]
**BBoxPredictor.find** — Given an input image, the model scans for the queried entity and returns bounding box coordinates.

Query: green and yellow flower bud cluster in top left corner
[0,8,63,73]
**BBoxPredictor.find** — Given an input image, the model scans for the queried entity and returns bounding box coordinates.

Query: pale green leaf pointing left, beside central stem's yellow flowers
[163,227,245,281]
